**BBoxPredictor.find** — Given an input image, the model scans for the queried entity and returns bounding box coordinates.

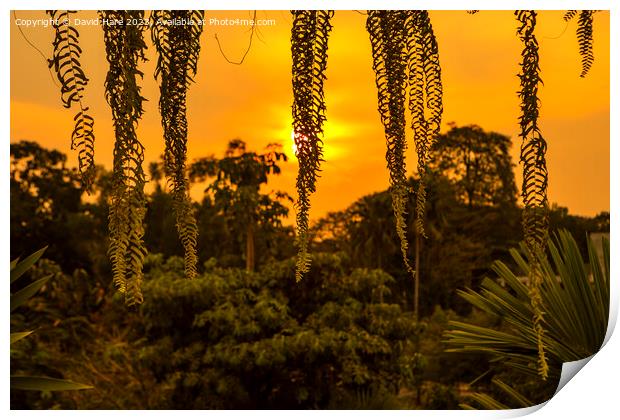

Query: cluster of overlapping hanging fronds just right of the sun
[366,10,443,275]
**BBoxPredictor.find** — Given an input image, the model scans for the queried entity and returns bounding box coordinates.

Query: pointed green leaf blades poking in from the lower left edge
[11,247,92,391]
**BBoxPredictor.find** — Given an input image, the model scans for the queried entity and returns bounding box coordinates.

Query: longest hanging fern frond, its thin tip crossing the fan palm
[515,10,549,379]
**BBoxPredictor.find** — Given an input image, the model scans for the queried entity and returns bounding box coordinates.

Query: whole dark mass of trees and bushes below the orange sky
[10,126,609,409]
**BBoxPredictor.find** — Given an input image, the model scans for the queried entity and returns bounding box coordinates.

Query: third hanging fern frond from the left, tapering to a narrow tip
[151,10,204,278]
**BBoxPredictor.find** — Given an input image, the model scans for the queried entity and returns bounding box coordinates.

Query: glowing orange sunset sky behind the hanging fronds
[10,11,609,219]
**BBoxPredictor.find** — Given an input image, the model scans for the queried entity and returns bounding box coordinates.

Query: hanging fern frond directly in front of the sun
[291,10,334,281]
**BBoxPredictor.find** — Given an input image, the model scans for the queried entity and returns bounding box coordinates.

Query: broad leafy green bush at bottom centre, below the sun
[141,254,416,408]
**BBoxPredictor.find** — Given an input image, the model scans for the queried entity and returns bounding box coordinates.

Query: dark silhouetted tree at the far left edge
[10,141,102,271]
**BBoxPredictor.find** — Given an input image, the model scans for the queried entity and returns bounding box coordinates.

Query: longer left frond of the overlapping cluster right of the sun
[366,10,414,275]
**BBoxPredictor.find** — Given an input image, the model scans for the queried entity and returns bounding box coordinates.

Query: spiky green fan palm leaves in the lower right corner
[446,231,609,407]
